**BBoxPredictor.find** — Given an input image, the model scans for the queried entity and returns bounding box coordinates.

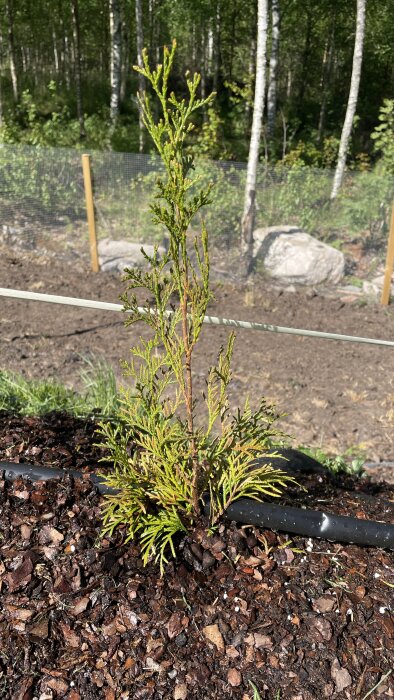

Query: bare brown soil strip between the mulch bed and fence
[0,246,394,462]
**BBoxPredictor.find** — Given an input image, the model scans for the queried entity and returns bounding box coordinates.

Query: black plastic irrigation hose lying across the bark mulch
[0,460,394,549]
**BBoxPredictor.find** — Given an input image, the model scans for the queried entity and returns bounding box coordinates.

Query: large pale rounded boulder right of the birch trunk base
[253,226,345,285]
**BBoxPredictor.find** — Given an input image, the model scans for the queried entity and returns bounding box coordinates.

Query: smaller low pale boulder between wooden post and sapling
[98,238,165,272]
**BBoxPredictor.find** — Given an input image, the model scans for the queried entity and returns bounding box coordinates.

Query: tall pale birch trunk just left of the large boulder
[241,0,268,275]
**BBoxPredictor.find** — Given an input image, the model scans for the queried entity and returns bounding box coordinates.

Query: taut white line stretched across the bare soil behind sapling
[0,287,394,347]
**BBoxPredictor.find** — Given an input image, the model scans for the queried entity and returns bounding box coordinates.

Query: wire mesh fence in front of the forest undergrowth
[0,145,394,278]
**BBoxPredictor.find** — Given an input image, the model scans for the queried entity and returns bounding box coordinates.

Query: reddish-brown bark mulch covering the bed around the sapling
[0,413,394,700]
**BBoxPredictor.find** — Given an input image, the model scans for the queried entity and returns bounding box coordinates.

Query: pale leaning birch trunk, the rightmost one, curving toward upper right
[331,0,366,200]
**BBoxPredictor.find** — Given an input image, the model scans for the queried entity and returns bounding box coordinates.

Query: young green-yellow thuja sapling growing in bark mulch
[100,41,293,573]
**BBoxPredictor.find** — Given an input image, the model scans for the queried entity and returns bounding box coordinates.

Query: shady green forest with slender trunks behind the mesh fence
[0,0,394,170]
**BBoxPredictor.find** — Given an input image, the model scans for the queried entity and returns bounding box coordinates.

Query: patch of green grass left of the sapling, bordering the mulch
[0,357,119,417]
